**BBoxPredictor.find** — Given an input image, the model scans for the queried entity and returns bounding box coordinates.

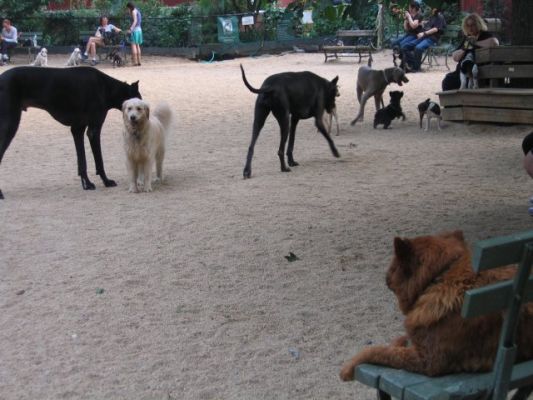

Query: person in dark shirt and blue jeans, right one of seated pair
[403,8,446,72]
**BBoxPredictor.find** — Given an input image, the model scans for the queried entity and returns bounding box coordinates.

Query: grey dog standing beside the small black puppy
[351,66,409,125]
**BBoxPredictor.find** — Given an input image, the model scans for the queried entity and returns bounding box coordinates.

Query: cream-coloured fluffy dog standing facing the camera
[122,98,172,193]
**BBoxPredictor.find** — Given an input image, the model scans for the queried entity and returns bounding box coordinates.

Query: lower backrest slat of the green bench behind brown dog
[461,276,533,318]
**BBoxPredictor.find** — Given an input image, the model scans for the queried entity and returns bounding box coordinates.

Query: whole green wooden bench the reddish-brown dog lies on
[355,231,533,400]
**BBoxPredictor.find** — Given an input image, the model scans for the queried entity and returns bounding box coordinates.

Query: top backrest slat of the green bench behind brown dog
[472,231,533,272]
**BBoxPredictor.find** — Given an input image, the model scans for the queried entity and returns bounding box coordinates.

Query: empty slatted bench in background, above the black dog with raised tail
[322,30,377,63]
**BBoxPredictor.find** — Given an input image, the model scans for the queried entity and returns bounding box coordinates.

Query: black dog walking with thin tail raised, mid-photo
[241,65,340,178]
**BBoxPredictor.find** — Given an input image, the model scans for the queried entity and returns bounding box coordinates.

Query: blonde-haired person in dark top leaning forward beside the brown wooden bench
[442,13,499,90]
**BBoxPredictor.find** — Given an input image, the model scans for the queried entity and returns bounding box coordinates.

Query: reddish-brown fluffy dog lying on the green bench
[340,231,533,381]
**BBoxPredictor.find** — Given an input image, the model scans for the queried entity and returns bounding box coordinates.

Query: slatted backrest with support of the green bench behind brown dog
[462,231,533,399]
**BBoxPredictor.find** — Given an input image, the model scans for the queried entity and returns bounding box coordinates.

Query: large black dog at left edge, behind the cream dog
[0,67,141,198]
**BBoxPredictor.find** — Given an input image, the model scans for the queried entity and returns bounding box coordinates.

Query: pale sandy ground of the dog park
[0,53,533,400]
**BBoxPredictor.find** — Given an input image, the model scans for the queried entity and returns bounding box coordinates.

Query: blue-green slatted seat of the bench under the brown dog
[355,360,533,400]
